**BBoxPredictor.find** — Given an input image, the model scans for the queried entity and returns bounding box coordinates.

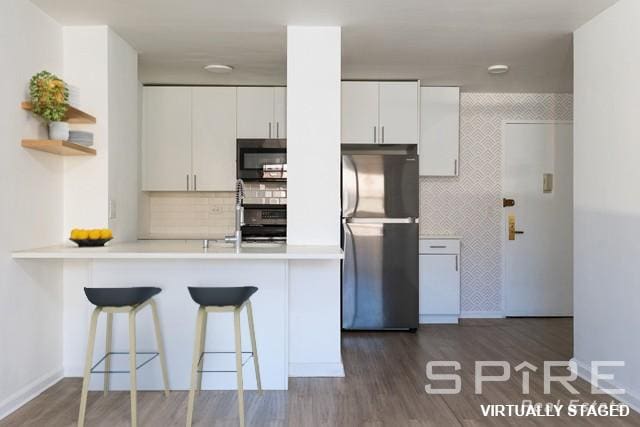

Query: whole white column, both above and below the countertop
[287,26,344,376]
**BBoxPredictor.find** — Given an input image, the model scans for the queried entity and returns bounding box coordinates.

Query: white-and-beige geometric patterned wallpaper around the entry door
[420,93,573,313]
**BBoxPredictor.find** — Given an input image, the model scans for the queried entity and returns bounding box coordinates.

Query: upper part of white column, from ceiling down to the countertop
[287,26,341,245]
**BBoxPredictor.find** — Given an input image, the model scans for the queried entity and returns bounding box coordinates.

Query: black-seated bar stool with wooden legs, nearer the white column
[187,286,262,427]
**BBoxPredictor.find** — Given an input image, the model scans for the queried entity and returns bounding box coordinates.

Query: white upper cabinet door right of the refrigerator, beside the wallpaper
[420,87,460,176]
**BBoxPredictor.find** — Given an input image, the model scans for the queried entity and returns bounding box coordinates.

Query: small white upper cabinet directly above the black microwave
[237,87,286,138]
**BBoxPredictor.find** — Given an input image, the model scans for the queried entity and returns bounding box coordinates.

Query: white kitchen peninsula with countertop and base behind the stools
[13,241,344,390]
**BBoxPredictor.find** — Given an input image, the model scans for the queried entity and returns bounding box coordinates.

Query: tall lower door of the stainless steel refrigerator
[342,222,419,329]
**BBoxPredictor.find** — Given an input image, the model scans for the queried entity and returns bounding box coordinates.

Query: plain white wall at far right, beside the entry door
[574,0,640,409]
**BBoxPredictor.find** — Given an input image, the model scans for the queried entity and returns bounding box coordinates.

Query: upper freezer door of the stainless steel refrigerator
[342,154,419,218]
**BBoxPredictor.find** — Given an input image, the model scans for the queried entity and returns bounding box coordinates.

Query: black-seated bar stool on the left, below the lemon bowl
[78,287,169,427]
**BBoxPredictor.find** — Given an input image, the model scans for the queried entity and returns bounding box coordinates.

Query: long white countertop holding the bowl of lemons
[12,240,343,260]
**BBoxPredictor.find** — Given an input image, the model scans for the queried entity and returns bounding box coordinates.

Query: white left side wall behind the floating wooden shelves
[0,0,63,418]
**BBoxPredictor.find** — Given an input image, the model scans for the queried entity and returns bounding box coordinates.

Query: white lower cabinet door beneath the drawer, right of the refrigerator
[420,255,460,315]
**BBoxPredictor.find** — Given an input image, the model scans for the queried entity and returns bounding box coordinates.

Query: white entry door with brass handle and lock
[503,123,573,316]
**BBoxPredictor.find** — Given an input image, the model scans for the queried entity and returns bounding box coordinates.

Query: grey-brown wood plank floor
[0,319,640,427]
